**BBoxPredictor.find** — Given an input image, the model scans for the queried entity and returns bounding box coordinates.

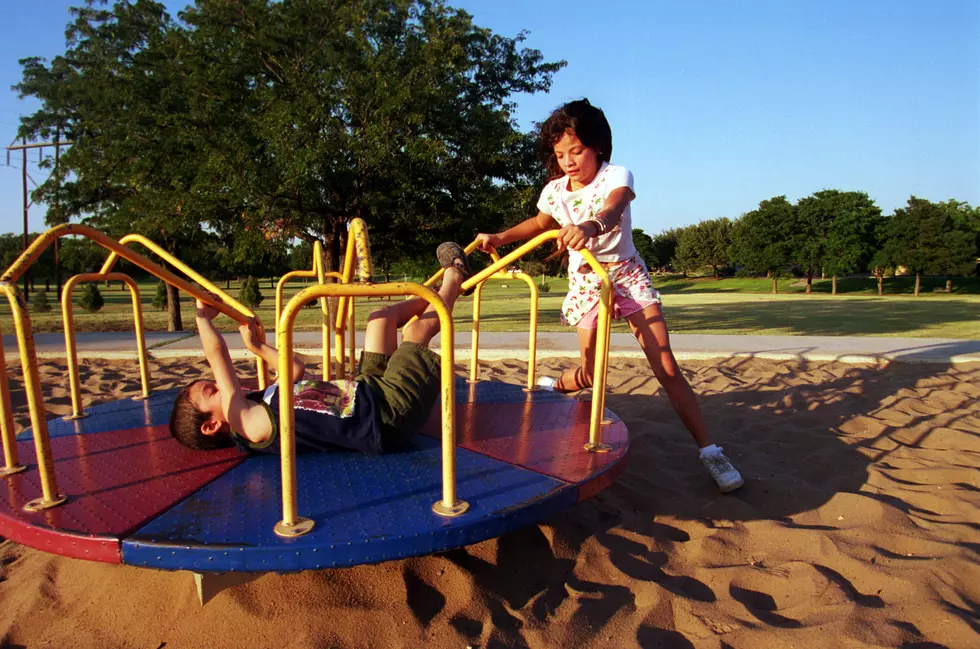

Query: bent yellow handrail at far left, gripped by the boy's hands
[0,223,265,511]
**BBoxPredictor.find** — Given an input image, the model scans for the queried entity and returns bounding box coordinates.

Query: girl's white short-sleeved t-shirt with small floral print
[538,162,636,272]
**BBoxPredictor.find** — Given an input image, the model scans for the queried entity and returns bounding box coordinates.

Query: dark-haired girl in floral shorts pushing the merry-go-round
[477,99,743,492]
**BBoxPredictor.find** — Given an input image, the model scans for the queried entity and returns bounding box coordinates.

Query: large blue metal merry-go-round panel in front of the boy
[122,436,577,572]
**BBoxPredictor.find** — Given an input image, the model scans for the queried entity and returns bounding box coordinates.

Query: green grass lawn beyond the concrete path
[0,277,980,339]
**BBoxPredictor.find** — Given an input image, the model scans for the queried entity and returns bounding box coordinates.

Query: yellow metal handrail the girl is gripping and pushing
[425,230,613,453]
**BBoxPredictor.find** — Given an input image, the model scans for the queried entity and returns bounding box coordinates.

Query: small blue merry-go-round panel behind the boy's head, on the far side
[31,388,180,440]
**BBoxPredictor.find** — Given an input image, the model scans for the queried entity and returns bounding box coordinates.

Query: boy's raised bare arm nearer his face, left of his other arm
[197,300,272,442]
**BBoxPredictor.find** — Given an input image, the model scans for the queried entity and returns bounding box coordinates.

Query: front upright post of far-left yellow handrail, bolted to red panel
[0,284,67,512]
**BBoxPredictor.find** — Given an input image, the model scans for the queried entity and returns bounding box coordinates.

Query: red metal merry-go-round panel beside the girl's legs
[423,398,629,486]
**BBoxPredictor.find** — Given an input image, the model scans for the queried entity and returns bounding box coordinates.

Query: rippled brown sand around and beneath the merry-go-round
[0,359,980,649]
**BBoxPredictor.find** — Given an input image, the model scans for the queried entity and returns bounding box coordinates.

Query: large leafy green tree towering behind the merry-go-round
[18,0,564,326]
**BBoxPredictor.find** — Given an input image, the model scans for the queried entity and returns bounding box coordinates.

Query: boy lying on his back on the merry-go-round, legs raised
[170,242,472,453]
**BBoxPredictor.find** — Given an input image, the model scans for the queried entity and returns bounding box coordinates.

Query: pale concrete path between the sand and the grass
[3,331,980,363]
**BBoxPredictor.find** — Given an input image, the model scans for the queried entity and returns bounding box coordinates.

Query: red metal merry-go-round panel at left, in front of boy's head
[0,425,245,563]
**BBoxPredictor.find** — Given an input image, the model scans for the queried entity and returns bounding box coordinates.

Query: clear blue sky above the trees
[0,0,980,238]
